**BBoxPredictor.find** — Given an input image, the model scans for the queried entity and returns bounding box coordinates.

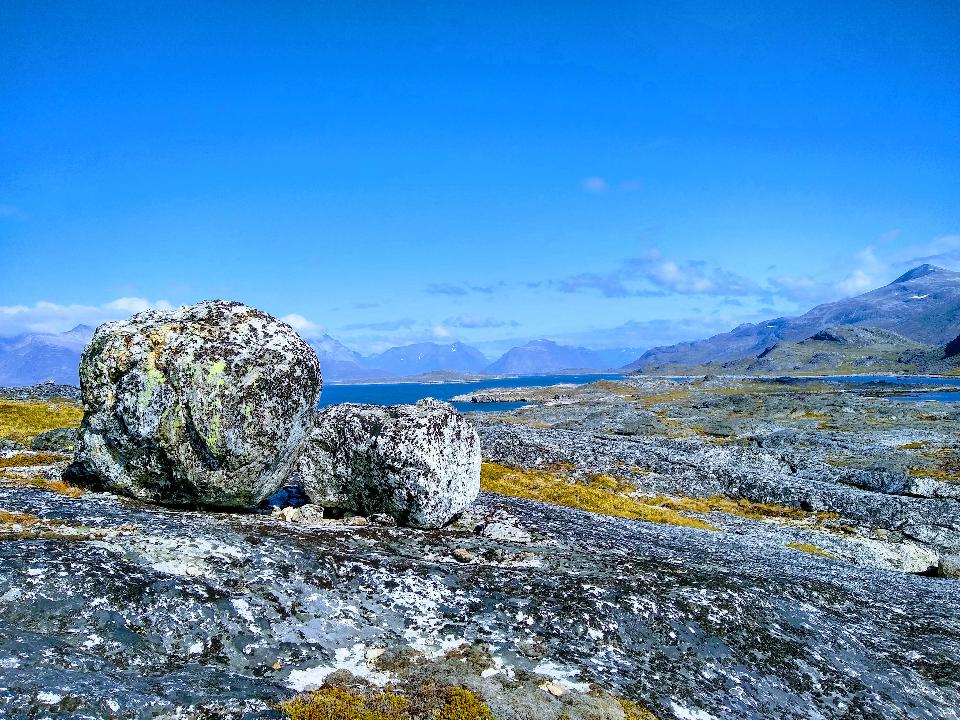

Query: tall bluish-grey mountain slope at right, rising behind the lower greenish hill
[624,265,960,374]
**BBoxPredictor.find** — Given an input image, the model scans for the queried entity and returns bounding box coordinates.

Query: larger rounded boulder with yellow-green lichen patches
[71,301,321,507]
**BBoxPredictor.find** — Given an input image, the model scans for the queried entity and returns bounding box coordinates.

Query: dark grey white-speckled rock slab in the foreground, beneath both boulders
[0,487,960,720]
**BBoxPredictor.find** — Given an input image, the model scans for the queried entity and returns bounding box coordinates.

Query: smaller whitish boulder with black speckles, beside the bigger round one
[297,399,480,528]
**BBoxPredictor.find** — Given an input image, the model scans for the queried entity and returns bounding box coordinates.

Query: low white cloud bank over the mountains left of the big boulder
[0,297,173,336]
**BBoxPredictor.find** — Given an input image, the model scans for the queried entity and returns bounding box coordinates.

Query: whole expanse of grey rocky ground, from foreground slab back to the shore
[0,378,960,720]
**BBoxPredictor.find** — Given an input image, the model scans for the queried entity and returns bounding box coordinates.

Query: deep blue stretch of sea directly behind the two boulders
[320,374,623,412]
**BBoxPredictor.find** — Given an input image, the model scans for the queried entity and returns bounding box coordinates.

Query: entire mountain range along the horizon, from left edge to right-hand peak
[13,265,960,385]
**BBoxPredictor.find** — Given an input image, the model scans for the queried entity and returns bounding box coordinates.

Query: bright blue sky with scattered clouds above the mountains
[0,1,960,353]
